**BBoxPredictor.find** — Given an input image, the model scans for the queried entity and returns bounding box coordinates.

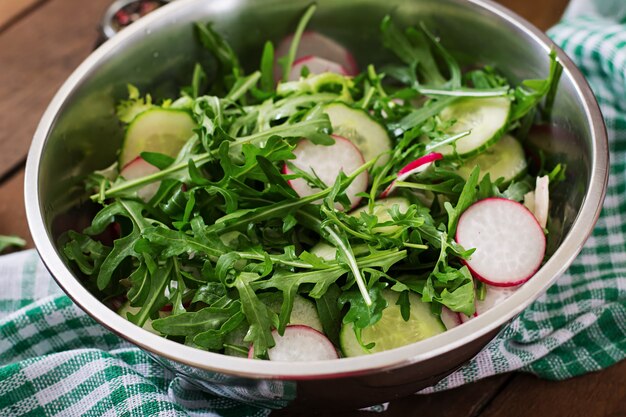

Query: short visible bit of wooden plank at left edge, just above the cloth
[0,170,33,248]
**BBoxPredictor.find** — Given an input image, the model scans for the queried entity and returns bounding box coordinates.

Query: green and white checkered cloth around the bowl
[0,0,626,416]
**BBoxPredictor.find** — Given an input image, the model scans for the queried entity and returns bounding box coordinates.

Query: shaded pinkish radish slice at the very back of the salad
[274,31,359,80]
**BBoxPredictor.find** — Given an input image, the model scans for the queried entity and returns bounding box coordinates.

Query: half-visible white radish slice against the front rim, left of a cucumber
[248,325,339,362]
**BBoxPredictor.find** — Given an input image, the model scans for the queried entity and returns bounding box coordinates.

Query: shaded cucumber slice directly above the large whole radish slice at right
[457,135,528,184]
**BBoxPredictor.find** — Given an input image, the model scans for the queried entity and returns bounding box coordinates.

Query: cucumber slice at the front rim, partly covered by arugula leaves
[339,290,446,357]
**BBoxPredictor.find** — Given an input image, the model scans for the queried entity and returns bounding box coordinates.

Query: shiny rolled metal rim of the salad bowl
[24,0,609,380]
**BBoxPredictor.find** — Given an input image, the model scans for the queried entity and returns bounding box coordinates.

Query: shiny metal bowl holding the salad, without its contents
[25,0,608,409]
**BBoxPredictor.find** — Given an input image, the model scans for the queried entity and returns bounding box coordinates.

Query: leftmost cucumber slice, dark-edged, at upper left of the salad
[119,108,196,167]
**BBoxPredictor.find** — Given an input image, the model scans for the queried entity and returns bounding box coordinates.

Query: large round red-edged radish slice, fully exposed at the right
[456,198,546,287]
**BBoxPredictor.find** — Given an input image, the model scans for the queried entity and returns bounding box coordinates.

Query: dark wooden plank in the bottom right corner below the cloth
[481,362,626,417]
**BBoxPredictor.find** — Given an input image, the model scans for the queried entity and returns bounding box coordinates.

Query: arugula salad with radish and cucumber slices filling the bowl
[59,6,564,360]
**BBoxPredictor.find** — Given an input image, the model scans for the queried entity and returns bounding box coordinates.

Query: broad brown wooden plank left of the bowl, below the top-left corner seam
[0,0,111,177]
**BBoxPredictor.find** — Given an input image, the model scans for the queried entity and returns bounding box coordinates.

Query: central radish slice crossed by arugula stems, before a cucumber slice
[283,135,369,210]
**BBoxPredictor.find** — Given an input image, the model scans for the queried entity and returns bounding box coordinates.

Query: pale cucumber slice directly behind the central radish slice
[324,102,391,166]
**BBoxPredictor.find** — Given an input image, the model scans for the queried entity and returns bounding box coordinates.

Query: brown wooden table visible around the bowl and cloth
[0,0,626,417]
